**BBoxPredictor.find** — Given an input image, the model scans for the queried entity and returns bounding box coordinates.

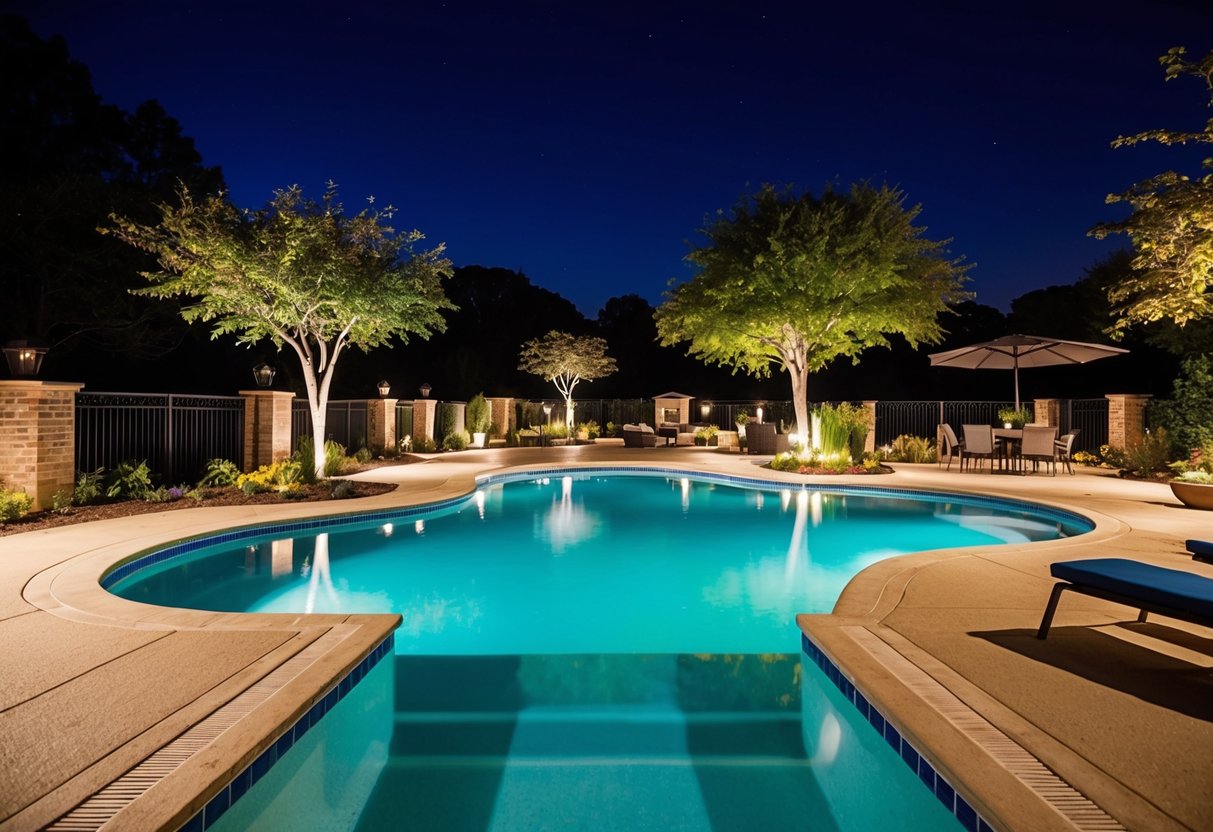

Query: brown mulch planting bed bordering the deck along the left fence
[0,480,395,537]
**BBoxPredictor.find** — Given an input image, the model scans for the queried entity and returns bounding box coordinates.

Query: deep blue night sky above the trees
[7,0,1213,317]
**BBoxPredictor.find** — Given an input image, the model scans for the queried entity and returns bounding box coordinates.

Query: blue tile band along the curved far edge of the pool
[101,466,1095,589]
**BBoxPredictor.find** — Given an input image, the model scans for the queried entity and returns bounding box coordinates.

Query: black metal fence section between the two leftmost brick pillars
[75,393,244,484]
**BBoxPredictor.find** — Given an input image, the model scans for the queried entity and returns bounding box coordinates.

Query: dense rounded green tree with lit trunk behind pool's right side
[656,183,967,432]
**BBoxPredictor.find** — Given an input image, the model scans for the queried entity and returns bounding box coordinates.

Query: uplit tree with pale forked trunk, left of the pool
[102,183,454,469]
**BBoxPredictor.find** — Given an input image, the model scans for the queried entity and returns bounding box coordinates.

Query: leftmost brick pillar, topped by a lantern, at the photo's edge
[0,381,84,511]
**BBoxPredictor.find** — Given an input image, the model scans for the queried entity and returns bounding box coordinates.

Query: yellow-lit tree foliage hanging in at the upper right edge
[1090,46,1213,335]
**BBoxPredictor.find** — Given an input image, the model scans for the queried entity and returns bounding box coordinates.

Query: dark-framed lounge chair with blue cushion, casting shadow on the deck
[1036,558,1213,639]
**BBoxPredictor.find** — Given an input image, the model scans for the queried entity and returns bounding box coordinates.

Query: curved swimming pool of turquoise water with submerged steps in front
[107,472,1090,830]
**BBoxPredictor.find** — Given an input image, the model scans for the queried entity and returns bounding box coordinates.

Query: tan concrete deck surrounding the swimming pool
[0,445,1213,830]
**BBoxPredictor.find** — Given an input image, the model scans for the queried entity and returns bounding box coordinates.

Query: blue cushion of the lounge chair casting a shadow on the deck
[1049,558,1213,619]
